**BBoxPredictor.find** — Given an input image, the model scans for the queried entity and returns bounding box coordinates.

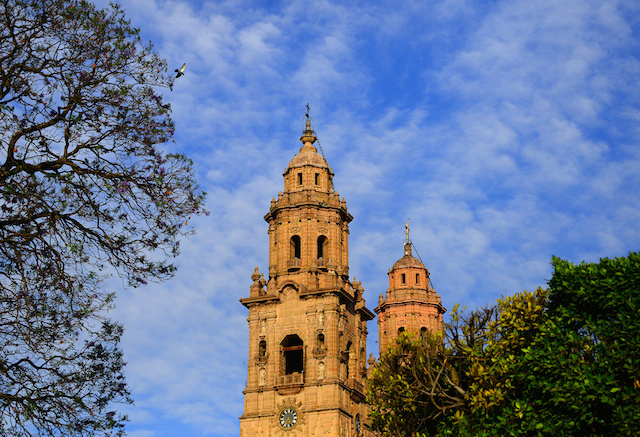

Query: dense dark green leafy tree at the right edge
[541,252,640,435]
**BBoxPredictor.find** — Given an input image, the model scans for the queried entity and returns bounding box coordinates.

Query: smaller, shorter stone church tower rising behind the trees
[374,223,445,356]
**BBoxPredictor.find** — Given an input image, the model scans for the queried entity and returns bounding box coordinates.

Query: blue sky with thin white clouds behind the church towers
[87,0,640,437]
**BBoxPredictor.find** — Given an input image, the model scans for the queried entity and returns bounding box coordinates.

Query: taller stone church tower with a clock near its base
[240,118,374,437]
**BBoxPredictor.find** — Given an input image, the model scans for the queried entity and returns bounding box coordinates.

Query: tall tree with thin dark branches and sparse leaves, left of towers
[0,0,204,436]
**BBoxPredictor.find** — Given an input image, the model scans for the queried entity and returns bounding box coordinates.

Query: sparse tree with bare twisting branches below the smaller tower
[367,306,495,437]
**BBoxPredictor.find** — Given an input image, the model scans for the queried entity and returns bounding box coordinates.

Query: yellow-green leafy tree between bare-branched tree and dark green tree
[454,288,548,436]
